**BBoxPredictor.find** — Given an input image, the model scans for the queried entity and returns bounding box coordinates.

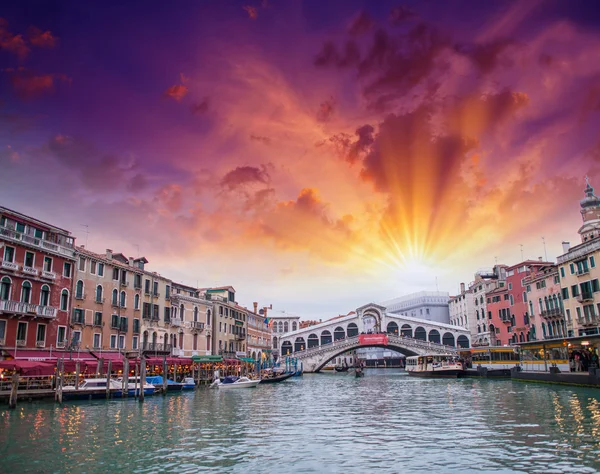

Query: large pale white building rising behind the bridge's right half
[380,291,450,324]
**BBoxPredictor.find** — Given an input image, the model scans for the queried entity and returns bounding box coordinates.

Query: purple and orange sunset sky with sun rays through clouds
[0,0,600,319]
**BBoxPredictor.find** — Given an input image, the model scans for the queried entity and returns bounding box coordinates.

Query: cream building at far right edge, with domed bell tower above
[557,182,600,336]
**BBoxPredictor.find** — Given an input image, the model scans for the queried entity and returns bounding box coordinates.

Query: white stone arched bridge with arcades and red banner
[274,303,471,372]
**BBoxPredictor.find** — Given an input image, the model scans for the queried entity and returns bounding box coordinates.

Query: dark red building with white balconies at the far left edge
[0,207,78,351]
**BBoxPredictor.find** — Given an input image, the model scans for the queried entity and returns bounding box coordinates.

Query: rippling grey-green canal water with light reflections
[0,369,600,474]
